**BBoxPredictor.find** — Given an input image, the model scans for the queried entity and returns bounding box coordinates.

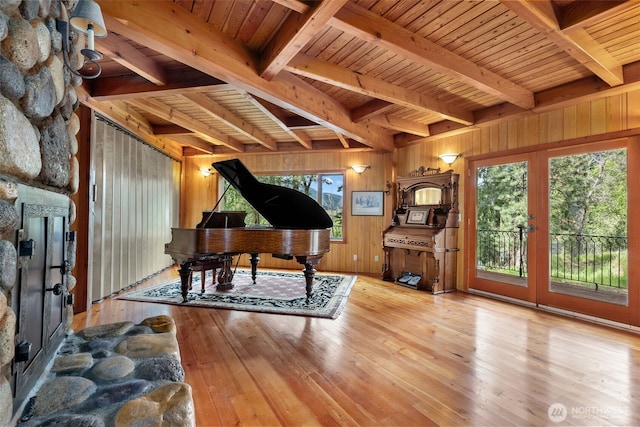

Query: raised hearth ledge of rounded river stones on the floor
[18,316,195,427]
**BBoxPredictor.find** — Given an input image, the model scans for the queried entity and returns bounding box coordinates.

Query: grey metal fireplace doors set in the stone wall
[11,193,69,408]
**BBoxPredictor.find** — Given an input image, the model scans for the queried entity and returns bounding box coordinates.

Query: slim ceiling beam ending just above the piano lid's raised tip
[127,99,244,152]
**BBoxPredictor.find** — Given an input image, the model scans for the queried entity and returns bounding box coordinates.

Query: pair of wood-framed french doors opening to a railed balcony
[465,139,640,325]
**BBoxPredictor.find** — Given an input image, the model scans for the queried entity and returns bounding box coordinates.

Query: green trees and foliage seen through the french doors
[476,149,627,288]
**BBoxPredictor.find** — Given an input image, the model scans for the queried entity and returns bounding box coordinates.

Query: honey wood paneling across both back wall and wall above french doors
[181,91,640,280]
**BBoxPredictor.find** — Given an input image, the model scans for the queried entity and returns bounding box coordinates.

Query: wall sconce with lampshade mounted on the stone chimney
[56,0,107,79]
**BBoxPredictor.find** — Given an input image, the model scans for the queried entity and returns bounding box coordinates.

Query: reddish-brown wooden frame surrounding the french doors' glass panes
[463,133,640,326]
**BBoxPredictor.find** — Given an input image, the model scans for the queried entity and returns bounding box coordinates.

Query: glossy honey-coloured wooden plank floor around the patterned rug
[73,269,640,426]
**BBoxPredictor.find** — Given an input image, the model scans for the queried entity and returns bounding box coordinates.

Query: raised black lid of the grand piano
[212,159,333,230]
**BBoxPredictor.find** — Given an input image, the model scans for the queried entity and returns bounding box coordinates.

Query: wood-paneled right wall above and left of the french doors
[398,91,640,289]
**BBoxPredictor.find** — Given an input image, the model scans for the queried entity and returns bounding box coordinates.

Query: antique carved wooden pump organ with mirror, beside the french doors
[382,167,459,294]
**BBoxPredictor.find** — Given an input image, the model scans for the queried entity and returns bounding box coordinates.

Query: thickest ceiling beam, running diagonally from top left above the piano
[99,0,394,152]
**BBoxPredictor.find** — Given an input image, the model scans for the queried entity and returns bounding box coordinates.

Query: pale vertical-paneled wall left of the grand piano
[88,118,180,301]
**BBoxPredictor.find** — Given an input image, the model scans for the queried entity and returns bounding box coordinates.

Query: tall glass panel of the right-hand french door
[541,147,629,319]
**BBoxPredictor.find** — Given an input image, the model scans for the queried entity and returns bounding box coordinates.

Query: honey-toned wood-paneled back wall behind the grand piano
[181,151,395,273]
